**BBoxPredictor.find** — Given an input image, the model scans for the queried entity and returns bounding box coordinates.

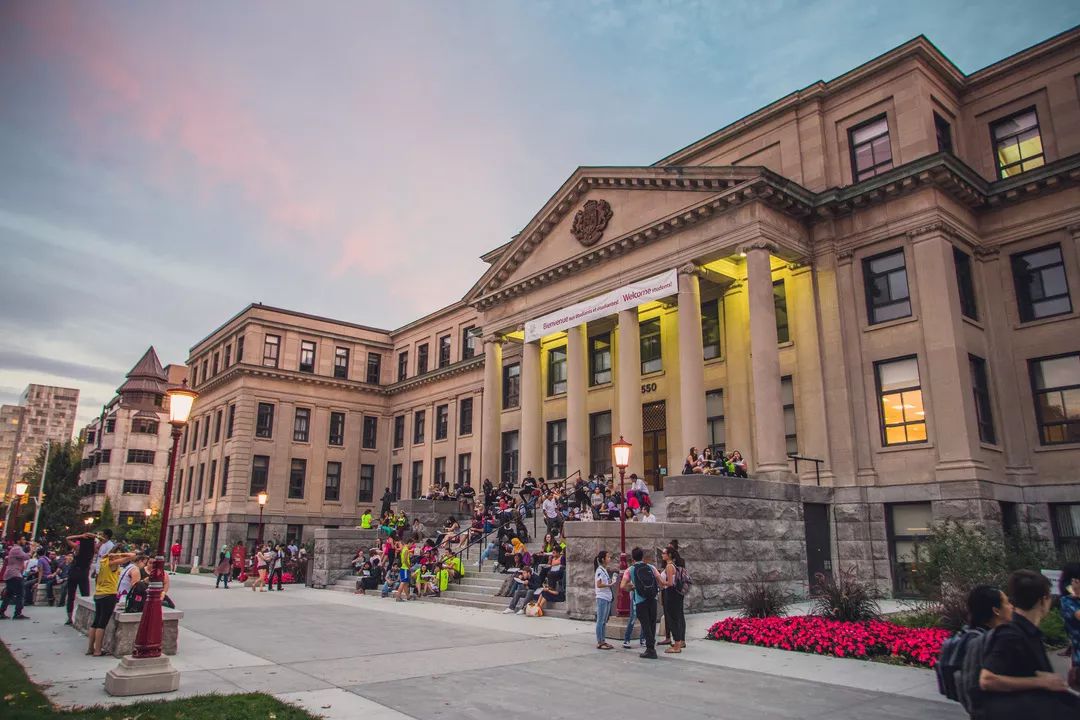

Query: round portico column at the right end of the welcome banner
[676,264,707,458]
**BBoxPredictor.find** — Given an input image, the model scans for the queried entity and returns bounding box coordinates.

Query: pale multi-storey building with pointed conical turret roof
[79,348,187,526]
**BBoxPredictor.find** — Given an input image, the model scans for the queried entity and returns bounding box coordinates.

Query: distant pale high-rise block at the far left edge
[0,384,79,494]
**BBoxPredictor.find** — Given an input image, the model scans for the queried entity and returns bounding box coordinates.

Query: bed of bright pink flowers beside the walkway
[708,615,949,667]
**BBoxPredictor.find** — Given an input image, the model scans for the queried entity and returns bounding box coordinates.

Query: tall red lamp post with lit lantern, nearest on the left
[132,380,199,657]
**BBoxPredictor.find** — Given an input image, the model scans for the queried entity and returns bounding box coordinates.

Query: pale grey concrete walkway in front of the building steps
[0,575,964,720]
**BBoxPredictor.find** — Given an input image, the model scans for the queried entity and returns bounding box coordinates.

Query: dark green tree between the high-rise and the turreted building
[19,440,82,540]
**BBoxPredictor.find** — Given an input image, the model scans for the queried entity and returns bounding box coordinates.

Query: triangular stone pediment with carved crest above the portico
[465,166,812,303]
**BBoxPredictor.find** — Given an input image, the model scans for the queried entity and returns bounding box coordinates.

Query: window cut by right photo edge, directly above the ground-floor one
[1029,353,1080,445]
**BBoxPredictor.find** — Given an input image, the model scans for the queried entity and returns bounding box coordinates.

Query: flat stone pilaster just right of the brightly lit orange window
[910,228,983,480]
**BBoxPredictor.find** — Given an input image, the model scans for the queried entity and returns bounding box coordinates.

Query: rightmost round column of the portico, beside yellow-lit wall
[741,242,788,475]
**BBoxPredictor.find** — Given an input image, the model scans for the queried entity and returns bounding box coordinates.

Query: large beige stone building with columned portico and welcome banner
[176,29,1080,594]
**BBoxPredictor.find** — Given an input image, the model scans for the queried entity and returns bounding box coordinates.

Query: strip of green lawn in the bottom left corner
[0,642,315,720]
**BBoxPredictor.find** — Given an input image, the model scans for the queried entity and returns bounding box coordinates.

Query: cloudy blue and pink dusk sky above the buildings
[0,0,1080,426]
